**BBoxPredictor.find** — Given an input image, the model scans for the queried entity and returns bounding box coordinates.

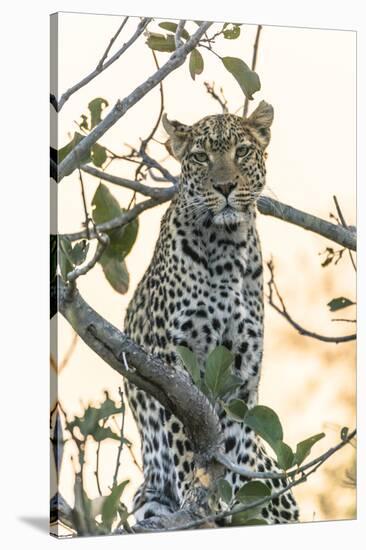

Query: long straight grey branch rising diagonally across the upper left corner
[58,22,212,181]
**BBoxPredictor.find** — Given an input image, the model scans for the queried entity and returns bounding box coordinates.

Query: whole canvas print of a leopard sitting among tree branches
[50,13,357,537]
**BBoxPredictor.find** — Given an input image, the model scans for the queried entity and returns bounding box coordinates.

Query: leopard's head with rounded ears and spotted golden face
[163,101,273,226]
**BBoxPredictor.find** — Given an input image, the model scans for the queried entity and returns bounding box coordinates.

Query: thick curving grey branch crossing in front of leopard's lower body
[59,278,221,464]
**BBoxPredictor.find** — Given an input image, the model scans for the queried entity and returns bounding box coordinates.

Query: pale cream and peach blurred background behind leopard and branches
[51,13,356,536]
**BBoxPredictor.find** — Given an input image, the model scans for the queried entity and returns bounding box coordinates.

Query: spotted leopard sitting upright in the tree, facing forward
[124,101,299,524]
